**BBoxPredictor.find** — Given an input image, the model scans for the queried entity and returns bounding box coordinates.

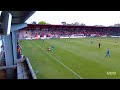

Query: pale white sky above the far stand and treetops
[26,11,120,26]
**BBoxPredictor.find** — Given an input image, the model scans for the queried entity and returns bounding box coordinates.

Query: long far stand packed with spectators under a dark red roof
[19,24,120,39]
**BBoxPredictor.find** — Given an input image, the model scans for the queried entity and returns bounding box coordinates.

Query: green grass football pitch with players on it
[20,38,120,79]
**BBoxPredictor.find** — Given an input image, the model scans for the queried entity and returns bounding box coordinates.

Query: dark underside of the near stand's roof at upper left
[1,11,35,24]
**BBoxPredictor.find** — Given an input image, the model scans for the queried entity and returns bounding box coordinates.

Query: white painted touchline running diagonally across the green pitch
[32,41,83,79]
